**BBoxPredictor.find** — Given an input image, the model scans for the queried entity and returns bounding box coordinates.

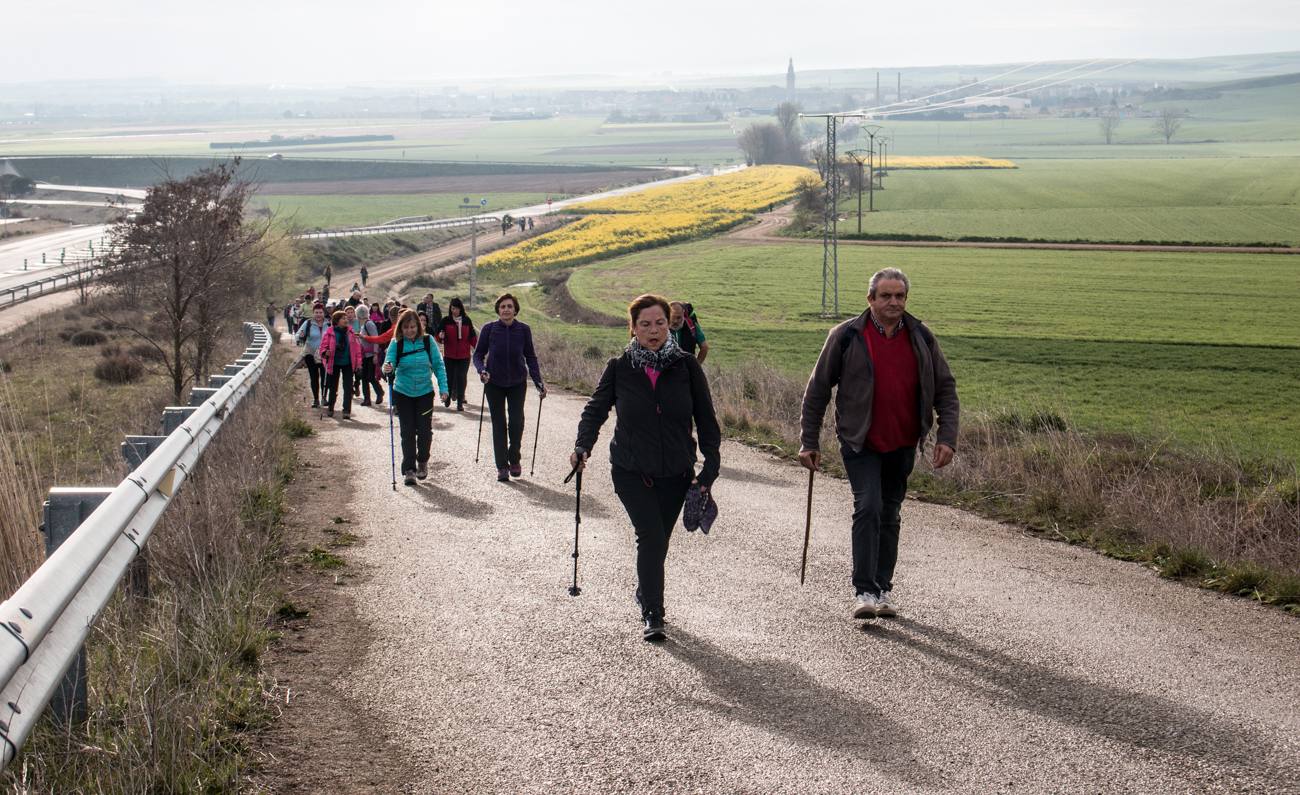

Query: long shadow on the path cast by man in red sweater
[863,618,1300,783]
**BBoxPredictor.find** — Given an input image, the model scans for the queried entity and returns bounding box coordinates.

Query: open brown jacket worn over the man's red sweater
[800,309,961,451]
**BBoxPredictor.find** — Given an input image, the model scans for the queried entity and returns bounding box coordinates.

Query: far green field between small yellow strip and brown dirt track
[840,157,1300,246]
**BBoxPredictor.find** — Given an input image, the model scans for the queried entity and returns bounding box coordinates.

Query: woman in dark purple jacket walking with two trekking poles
[473,292,546,482]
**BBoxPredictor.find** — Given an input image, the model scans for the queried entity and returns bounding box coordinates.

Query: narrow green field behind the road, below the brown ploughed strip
[254,194,553,229]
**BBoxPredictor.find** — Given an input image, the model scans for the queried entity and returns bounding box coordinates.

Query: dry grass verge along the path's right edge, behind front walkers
[537,327,1300,613]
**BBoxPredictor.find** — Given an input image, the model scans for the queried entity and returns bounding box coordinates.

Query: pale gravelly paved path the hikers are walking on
[309,379,1300,794]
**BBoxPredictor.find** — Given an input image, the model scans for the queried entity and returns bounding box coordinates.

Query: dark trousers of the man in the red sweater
[840,447,917,596]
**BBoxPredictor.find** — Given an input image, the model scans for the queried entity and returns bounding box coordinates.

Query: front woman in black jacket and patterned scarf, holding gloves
[569,295,722,640]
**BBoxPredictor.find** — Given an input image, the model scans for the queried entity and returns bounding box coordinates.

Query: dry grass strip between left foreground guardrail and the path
[0,348,301,792]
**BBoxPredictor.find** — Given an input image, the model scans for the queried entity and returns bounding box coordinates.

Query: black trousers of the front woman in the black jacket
[612,469,690,614]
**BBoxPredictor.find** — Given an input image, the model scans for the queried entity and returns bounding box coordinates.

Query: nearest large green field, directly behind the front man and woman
[556,239,1300,460]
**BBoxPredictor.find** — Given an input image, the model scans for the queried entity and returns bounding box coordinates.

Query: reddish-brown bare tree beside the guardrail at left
[101,158,276,401]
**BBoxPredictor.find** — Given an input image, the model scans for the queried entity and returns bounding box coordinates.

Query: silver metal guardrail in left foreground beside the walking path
[0,323,272,770]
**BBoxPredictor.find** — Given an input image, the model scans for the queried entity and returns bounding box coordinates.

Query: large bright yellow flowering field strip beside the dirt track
[478,166,813,270]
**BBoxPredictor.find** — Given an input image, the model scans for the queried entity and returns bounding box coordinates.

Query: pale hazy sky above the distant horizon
[10,0,1300,84]
